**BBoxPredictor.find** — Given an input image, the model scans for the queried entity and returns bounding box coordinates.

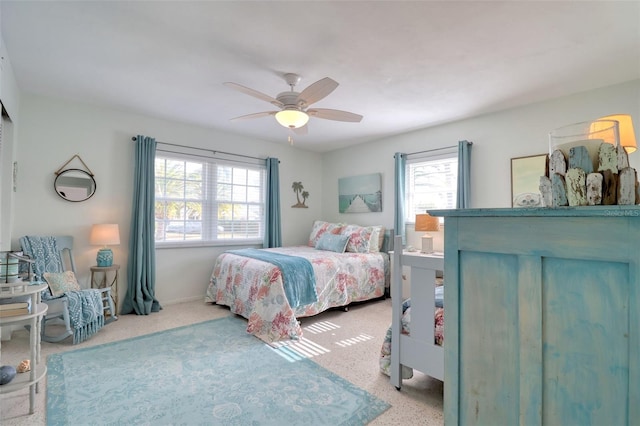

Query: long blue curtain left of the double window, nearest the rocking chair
[120,135,162,315]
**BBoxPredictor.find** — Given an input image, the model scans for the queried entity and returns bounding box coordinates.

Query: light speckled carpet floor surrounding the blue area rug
[0,299,443,426]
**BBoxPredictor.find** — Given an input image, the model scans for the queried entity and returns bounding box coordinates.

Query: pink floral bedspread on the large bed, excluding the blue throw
[205,246,389,341]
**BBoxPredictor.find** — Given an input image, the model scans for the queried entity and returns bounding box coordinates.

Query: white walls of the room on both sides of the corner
[12,80,640,304]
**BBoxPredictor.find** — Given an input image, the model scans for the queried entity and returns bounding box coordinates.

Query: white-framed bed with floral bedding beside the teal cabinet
[380,237,444,389]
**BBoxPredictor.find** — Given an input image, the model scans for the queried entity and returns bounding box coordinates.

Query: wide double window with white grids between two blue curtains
[155,150,266,246]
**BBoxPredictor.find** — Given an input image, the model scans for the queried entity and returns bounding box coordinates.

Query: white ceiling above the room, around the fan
[0,0,640,152]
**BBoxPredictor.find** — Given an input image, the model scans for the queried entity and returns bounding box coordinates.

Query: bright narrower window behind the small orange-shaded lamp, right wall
[405,150,458,223]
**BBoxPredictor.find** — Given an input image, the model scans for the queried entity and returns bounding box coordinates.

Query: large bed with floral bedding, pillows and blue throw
[205,220,390,342]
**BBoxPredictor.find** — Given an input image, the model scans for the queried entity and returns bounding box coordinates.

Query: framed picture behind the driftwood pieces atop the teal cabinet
[511,154,547,207]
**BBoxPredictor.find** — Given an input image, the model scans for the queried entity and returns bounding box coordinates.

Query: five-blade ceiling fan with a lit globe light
[224,73,362,134]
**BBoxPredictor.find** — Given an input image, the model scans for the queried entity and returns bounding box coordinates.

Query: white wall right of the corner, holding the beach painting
[322,80,640,250]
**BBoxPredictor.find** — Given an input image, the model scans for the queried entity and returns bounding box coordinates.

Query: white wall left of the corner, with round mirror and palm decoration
[12,94,322,304]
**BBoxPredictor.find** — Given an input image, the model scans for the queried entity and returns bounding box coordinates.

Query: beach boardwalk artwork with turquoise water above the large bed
[338,173,382,213]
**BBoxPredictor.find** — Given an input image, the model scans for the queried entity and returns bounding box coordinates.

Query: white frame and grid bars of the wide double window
[154,151,267,249]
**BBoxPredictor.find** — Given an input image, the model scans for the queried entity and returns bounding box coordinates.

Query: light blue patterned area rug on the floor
[47,317,389,426]
